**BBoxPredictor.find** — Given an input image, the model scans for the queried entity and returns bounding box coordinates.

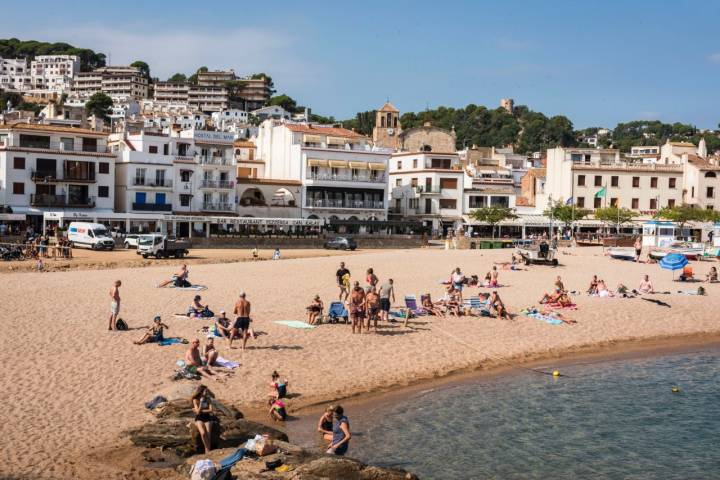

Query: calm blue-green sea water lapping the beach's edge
[348,349,720,480]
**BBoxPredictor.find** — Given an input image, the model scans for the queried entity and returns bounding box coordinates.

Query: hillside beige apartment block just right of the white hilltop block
[72,66,148,101]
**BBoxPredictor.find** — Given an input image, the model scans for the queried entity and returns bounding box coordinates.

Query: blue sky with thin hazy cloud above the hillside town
[0,0,720,128]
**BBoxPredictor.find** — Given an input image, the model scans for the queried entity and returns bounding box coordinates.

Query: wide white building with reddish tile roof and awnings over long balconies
[256,120,390,225]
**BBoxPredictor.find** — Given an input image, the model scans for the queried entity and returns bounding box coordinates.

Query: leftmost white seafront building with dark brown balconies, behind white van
[0,123,115,225]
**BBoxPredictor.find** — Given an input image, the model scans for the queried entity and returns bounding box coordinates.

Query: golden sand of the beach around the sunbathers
[0,248,720,478]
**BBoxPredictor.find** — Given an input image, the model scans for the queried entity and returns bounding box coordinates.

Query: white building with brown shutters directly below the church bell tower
[389,152,464,233]
